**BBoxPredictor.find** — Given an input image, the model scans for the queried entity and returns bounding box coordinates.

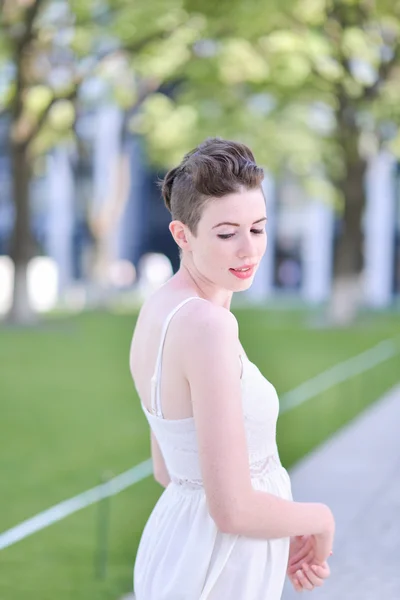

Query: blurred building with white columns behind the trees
[0,106,400,307]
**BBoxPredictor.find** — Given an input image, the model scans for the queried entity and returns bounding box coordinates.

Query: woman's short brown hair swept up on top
[161,138,264,235]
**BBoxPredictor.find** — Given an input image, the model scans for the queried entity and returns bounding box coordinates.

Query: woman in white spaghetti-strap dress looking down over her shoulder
[130,139,334,600]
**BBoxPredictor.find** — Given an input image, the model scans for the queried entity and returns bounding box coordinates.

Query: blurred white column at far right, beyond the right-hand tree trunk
[364,152,396,308]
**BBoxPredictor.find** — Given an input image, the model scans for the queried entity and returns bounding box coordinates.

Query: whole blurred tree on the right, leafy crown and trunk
[138,0,400,322]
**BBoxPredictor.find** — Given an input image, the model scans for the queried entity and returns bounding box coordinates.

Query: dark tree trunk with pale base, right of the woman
[329,156,366,326]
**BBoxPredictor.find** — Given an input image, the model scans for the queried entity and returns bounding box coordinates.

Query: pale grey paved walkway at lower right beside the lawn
[282,384,400,600]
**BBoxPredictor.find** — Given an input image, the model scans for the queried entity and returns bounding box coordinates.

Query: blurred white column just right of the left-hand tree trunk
[46,146,75,292]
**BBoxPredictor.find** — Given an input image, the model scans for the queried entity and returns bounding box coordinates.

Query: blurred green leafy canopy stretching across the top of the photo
[0,0,400,201]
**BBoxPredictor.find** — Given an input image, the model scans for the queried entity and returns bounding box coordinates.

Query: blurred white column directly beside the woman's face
[245,173,275,303]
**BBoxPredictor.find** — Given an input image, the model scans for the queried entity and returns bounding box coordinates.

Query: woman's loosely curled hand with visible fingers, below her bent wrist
[287,536,330,592]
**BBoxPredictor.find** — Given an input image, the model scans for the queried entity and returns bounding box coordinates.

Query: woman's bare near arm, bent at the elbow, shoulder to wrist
[180,303,334,561]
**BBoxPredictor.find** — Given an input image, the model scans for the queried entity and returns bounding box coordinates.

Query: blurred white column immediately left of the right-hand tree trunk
[302,200,334,303]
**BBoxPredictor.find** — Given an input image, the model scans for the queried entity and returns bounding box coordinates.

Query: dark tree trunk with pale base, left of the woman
[7,143,36,325]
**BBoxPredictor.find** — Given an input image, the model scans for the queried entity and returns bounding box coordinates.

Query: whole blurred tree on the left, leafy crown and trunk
[0,0,203,323]
